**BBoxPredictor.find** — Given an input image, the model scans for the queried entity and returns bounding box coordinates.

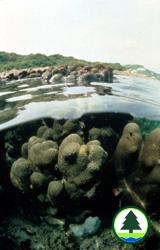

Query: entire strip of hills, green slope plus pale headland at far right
[0,51,160,80]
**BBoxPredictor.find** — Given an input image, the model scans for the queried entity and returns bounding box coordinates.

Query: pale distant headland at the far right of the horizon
[124,64,160,80]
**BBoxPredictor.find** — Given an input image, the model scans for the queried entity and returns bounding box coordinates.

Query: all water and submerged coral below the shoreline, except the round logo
[0,71,160,250]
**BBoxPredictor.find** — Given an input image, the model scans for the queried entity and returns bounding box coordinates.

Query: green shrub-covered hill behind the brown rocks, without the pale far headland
[0,52,126,71]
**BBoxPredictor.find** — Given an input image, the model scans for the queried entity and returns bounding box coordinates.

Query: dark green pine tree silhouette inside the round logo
[121,210,142,233]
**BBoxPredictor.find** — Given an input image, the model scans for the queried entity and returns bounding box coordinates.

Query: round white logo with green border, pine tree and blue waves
[112,206,150,244]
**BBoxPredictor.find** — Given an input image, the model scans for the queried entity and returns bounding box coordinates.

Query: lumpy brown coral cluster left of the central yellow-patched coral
[10,136,58,193]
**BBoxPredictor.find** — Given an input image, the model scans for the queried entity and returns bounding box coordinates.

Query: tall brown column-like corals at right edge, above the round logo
[111,123,160,212]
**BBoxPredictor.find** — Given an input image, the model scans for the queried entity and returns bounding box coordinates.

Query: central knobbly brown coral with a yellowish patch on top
[58,134,108,199]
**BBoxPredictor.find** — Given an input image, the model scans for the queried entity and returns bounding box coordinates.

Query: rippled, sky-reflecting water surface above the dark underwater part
[0,75,160,129]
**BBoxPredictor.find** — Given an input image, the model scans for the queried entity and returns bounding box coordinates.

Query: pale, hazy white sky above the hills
[0,0,160,73]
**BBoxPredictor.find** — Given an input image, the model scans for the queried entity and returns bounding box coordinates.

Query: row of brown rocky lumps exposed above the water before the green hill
[0,63,113,85]
